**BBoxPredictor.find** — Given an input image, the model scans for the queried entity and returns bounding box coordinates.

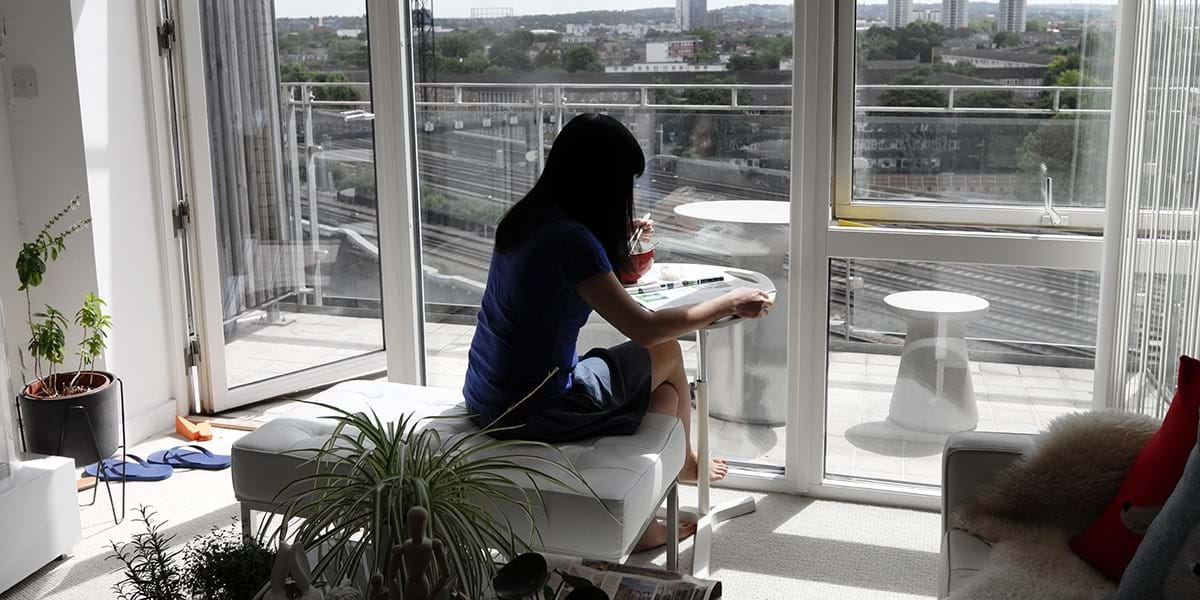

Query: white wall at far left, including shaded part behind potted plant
[0,0,181,442]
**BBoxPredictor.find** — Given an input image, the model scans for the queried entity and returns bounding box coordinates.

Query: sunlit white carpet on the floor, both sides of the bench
[0,430,940,600]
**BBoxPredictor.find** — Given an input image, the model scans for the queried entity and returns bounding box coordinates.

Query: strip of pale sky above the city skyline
[275,0,1116,18]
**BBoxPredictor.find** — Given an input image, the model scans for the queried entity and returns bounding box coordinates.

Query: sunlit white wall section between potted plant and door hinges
[71,0,182,439]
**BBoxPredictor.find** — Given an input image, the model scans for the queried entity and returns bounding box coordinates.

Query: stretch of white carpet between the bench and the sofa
[632,488,941,600]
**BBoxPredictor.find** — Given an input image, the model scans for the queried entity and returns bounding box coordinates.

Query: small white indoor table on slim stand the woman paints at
[624,263,774,578]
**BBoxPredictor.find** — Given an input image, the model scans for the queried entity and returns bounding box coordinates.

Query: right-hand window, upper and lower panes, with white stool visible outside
[812,0,1117,496]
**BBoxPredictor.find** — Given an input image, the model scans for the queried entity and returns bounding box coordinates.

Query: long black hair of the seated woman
[496,113,646,269]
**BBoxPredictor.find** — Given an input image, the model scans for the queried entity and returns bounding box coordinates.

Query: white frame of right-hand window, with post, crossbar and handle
[787,0,1113,510]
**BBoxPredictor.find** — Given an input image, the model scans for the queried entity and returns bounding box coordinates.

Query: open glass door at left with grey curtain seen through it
[181,0,384,410]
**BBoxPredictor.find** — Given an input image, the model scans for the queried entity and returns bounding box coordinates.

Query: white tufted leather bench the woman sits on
[232,382,685,570]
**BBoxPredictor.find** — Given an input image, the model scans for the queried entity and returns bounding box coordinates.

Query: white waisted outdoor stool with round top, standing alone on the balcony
[883,292,989,433]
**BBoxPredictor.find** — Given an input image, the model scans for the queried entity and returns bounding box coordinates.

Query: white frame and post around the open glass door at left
[168,0,425,414]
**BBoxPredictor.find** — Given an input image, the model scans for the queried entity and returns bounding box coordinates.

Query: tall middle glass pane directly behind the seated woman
[410,0,793,475]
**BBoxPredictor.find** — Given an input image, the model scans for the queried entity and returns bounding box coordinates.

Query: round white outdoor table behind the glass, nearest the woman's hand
[674,200,791,427]
